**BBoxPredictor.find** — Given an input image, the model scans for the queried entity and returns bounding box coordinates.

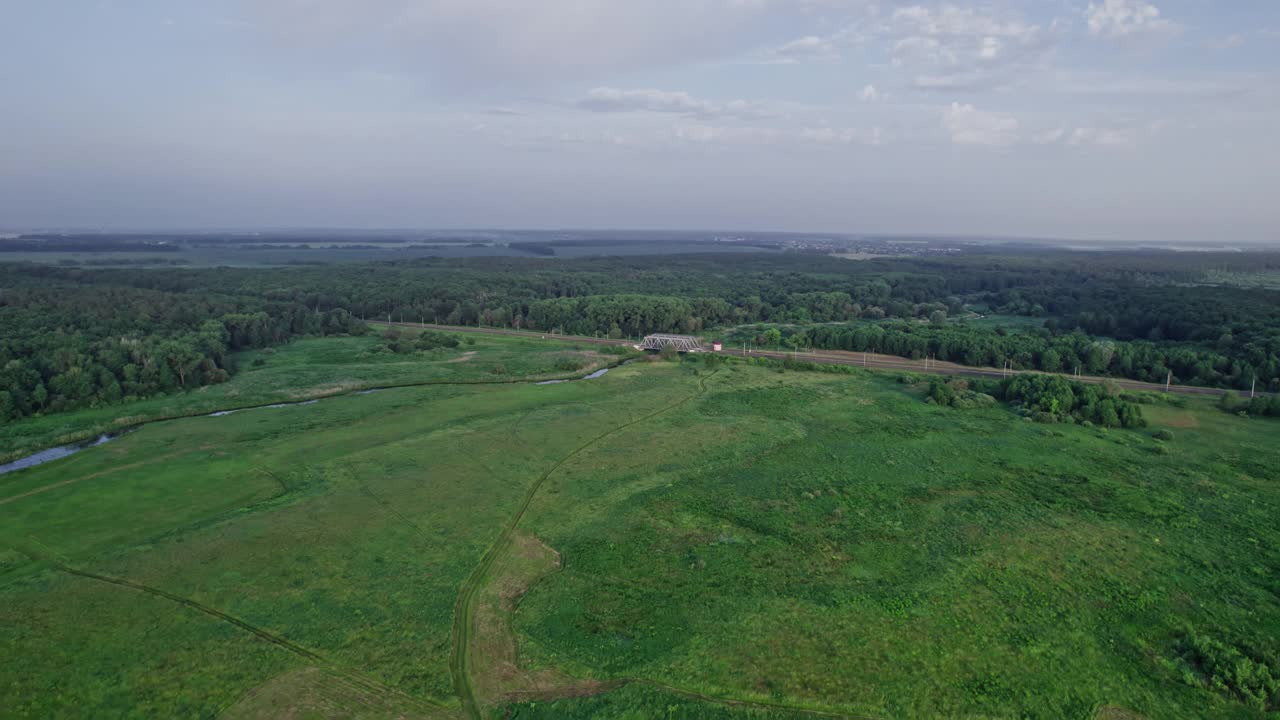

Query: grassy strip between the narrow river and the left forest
[0,328,618,462]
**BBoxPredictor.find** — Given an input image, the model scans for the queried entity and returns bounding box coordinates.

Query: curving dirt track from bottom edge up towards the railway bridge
[449,373,716,720]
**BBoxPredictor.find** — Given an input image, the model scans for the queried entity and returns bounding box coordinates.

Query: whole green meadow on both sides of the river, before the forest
[0,338,1280,719]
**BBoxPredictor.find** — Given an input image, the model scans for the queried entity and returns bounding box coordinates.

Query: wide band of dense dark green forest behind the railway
[0,250,1280,420]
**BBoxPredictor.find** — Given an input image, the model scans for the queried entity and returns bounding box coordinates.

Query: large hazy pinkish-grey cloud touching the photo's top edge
[238,0,814,88]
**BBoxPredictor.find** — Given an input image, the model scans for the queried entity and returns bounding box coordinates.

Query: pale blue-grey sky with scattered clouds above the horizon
[0,0,1280,242]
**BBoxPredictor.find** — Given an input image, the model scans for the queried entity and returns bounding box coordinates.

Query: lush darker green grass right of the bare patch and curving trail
[504,363,1280,717]
